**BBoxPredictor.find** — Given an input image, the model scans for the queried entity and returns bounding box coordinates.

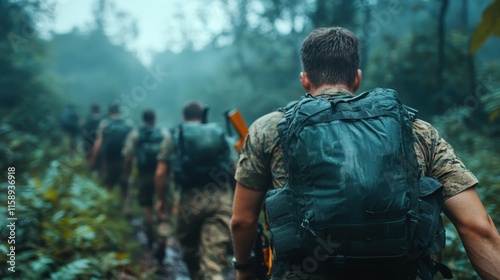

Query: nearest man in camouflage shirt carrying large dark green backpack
[231,27,500,280]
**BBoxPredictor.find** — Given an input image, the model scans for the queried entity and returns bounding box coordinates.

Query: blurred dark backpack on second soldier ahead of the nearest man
[136,126,163,173]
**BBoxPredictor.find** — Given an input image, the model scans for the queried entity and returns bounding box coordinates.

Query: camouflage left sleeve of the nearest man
[235,112,282,191]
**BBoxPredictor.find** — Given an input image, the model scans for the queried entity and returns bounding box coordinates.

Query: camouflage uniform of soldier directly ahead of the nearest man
[158,131,233,280]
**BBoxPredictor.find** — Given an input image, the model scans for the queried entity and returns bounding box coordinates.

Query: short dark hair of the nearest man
[300,27,359,87]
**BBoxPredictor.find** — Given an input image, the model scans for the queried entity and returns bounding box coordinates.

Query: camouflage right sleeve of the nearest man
[417,121,478,199]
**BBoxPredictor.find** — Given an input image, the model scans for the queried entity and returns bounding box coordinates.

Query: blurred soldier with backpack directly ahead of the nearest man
[156,101,234,280]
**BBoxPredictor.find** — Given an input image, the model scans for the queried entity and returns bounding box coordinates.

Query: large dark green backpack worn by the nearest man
[265,88,451,279]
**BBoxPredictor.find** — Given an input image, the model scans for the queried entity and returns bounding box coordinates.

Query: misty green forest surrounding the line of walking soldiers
[0,0,500,279]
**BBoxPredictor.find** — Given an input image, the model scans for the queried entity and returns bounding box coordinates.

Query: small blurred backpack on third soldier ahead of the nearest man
[102,119,132,160]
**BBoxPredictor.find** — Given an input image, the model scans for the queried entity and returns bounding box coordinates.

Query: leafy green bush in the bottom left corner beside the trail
[0,161,140,279]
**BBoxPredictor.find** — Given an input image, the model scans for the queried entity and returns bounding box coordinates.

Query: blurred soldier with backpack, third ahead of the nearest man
[89,103,133,210]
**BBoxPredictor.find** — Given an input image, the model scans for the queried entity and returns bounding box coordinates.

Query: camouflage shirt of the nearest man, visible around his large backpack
[235,89,478,279]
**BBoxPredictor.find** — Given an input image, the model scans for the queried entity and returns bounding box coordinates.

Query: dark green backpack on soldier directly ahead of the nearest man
[172,122,230,188]
